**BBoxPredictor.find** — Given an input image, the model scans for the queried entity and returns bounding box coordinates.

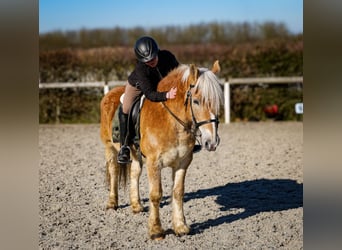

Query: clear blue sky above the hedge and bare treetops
[39,0,303,33]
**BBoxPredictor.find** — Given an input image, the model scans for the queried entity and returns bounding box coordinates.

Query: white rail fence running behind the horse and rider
[39,76,303,123]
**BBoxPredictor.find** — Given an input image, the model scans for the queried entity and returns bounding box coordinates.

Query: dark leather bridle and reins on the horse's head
[162,84,220,146]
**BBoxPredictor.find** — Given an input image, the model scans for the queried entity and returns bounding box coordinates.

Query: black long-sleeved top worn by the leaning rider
[128,50,179,102]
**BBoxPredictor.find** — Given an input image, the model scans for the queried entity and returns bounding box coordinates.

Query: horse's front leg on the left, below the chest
[146,160,165,240]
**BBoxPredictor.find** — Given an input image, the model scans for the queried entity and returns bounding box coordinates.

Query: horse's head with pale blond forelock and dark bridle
[185,61,223,151]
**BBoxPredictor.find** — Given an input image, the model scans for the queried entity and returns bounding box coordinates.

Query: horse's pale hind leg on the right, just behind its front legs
[130,160,144,213]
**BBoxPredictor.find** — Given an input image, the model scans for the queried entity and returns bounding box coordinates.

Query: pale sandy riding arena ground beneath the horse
[39,122,303,250]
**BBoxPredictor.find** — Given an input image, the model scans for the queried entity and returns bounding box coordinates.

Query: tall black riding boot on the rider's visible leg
[118,107,131,164]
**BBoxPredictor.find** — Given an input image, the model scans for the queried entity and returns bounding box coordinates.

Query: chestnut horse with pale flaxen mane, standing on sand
[101,61,223,239]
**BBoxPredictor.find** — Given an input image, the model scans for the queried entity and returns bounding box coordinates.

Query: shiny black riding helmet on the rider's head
[134,36,159,63]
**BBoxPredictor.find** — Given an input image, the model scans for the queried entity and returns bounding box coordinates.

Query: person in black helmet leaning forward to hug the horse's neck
[118,36,179,164]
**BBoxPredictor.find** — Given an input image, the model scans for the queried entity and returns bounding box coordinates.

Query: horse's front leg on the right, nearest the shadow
[172,167,190,236]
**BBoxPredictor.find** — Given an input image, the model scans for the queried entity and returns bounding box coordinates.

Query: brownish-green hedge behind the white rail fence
[39,37,303,123]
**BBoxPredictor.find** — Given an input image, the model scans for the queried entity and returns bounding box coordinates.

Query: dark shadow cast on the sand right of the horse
[179,179,303,234]
